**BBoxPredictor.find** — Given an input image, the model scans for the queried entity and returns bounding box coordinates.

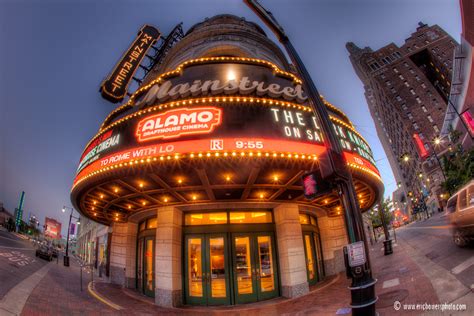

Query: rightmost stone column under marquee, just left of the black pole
[318,216,348,276]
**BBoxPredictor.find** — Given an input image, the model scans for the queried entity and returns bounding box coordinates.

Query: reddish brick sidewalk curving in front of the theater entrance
[12,241,446,316]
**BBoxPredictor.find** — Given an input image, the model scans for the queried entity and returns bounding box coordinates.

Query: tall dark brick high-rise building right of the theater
[346,22,457,215]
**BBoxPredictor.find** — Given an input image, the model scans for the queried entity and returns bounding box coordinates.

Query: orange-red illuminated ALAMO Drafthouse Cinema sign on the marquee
[136,107,222,142]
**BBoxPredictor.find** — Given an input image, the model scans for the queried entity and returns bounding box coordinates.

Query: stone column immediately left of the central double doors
[155,206,183,307]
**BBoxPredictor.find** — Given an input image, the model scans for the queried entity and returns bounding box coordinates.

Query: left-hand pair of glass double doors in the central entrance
[185,234,230,305]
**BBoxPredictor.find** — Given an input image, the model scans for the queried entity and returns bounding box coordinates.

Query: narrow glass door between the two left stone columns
[137,237,155,297]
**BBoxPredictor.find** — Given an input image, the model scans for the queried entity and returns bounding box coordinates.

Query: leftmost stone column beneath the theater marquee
[110,222,138,288]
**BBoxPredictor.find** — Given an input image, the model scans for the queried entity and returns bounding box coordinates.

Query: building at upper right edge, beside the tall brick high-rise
[441,0,474,149]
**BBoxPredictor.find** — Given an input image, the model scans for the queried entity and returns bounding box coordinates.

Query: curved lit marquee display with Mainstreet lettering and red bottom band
[75,63,378,183]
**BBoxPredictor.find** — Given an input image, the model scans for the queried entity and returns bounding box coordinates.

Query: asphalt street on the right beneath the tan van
[396,213,474,288]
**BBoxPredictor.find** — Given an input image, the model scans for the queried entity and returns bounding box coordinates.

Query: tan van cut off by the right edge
[446,180,474,247]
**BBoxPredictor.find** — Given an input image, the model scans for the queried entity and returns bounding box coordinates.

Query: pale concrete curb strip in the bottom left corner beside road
[0,263,52,315]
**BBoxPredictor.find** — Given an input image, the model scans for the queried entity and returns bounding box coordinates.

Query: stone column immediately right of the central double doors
[273,204,309,298]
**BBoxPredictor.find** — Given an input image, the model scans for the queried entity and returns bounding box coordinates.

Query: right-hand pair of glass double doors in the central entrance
[232,233,278,304]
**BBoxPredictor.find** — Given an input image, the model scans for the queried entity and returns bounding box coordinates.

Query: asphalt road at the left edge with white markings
[0,230,48,299]
